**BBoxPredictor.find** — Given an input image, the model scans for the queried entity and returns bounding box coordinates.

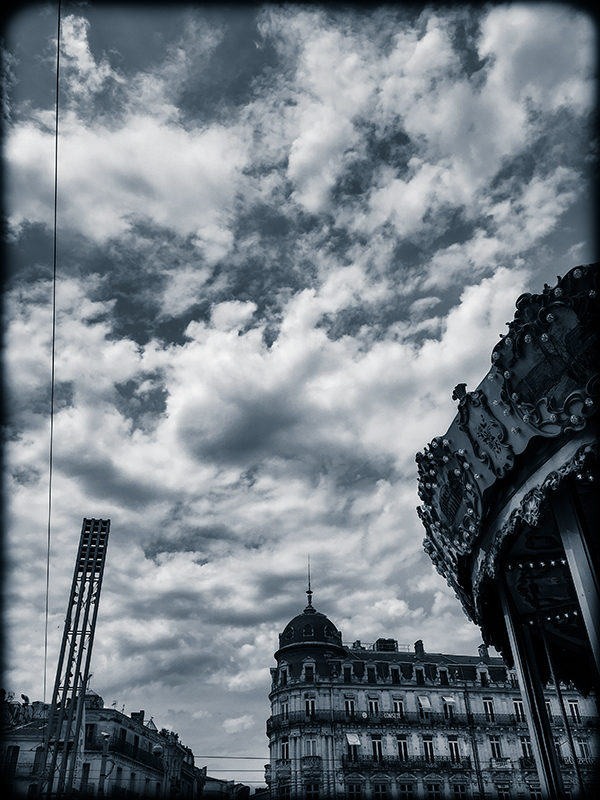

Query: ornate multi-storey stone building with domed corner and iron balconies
[265,592,598,800]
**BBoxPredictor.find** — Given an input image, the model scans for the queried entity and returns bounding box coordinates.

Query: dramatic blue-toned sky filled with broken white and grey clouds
[2,2,597,785]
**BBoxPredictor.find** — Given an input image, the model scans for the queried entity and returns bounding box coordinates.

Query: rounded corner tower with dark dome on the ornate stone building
[266,583,347,798]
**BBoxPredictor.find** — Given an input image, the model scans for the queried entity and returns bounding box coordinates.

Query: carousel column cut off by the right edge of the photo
[550,485,600,679]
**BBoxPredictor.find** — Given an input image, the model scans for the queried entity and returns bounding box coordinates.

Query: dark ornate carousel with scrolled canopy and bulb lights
[417,264,600,800]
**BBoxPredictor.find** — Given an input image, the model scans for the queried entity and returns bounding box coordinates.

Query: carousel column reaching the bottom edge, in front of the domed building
[498,574,565,800]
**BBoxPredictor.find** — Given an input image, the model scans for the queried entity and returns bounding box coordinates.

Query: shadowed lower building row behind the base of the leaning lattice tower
[0,692,206,800]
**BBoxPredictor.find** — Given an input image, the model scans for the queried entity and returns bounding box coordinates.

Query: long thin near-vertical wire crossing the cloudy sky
[44,0,60,703]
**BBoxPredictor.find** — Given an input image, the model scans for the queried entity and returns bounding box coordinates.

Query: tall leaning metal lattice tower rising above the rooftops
[38,519,110,800]
